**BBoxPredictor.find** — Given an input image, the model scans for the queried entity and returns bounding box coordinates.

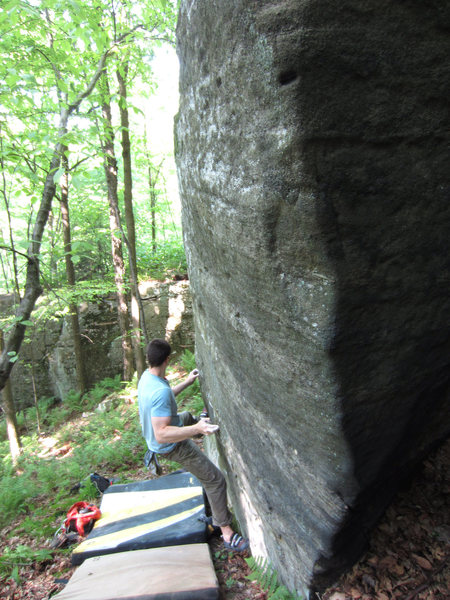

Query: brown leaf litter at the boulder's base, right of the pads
[213,440,450,600]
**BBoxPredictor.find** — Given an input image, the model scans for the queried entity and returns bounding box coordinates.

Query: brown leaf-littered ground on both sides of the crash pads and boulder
[0,441,450,600]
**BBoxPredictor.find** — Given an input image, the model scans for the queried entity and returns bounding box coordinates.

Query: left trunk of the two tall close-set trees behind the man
[102,71,134,381]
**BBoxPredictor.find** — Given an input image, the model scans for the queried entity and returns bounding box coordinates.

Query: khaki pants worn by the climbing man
[162,412,232,527]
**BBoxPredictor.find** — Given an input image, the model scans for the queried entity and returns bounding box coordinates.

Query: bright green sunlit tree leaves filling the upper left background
[0,0,179,293]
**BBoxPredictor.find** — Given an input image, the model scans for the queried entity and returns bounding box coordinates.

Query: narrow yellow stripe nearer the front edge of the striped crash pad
[73,506,204,554]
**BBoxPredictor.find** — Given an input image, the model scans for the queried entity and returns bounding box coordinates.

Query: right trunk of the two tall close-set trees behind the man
[117,59,145,378]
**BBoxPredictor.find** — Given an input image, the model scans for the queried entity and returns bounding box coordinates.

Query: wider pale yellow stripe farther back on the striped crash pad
[95,487,203,531]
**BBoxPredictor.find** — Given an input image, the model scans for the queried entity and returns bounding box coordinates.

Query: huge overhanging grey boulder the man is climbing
[176,0,450,593]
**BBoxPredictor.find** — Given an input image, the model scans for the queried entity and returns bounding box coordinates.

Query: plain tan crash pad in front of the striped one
[53,544,219,600]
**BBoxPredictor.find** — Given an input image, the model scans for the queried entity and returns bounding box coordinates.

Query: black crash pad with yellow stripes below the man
[72,472,206,565]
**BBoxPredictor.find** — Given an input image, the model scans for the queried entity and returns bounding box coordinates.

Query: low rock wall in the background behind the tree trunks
[0,281,194,409]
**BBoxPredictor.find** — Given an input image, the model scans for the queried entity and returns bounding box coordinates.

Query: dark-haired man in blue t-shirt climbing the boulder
[138,339,249,552]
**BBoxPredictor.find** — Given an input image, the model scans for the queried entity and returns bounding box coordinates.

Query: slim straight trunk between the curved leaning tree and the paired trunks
[60,147,86,394]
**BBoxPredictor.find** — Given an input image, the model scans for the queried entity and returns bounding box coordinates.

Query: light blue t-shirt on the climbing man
[138,369,182,454]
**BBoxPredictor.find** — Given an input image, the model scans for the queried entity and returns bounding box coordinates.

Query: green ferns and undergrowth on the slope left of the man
[0,376,144,535]
